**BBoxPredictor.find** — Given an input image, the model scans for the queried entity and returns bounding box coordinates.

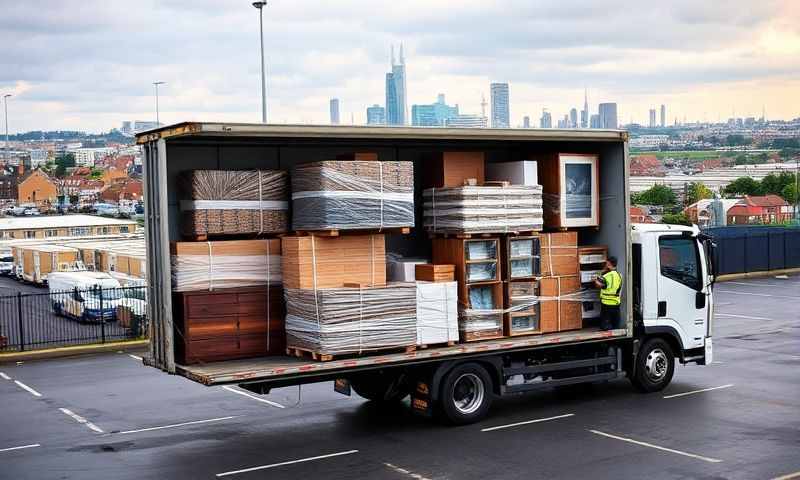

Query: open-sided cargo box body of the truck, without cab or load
[137,123,633,385]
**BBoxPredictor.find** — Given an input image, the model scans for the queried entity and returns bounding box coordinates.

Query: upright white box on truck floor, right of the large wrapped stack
[417,282,458,345]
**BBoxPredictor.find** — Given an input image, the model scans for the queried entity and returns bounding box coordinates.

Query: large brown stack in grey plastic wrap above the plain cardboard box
[292,160,414,230]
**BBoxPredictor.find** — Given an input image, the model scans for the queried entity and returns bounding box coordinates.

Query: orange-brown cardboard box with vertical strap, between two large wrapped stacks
[281,234,386,288]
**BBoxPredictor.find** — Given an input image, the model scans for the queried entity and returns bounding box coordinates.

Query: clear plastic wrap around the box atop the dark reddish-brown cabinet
[171,255,281,292]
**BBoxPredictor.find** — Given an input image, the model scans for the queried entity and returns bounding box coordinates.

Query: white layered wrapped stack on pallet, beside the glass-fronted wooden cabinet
[423,185,542,233]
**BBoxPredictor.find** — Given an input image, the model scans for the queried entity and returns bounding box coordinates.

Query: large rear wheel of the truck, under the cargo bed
[438,363,494,425]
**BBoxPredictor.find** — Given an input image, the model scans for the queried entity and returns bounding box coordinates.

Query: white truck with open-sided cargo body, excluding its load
[137,122,714,424]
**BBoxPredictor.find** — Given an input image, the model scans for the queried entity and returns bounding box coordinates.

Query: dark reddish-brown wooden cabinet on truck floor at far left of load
[172,286,286,365]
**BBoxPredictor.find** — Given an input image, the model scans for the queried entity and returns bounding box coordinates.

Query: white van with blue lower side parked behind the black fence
[47,272,124,322]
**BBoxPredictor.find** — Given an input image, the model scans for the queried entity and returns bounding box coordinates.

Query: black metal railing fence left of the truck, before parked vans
[0,286,149,352]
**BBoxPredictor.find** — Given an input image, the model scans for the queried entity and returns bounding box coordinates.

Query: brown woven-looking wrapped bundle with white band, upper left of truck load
[180,170,289,237]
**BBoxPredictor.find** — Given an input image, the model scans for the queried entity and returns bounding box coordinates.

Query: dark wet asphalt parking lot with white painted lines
[0,277,800,480]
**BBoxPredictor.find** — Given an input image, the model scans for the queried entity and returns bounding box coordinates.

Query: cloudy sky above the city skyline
[0,0,800,132]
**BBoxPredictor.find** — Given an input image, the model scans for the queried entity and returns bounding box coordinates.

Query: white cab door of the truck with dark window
[658,235,709,349]
